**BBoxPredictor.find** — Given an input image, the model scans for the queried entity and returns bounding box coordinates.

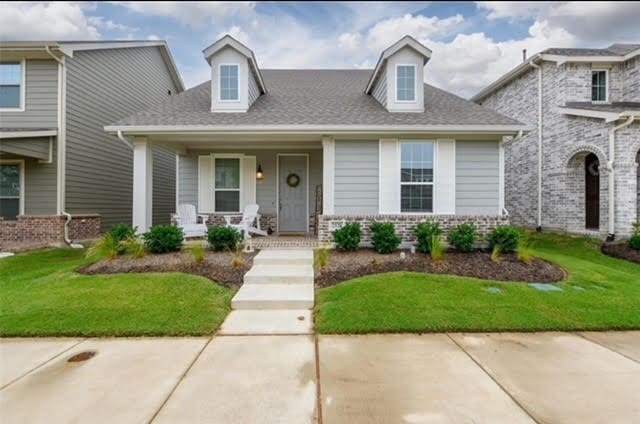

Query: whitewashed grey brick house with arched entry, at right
[472,44,640,242]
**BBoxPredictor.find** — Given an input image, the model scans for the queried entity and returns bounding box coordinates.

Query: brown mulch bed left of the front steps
[77,252,255,287]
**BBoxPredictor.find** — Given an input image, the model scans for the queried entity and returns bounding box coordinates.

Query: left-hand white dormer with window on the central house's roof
[203,35,267,112]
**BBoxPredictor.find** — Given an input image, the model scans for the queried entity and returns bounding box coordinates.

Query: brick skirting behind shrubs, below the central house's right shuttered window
[318,215,509,245]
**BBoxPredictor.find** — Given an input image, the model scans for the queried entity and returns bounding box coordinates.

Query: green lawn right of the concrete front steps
[316,234,640,333]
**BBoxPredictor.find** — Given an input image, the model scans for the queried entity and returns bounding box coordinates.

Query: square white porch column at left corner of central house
[133,137,153,234]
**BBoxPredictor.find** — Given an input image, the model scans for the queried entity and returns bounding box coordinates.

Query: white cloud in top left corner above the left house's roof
[0,2,100,40]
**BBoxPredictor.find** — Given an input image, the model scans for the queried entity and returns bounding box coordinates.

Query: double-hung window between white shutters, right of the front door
[400,141,433,212]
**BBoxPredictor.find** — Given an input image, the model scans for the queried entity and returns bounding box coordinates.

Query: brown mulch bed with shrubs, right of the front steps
[315,249,566,287]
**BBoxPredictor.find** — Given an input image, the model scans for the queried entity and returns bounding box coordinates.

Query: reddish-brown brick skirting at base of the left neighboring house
[0,214,100,243]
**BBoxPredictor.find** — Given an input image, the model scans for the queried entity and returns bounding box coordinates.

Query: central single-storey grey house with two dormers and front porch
[105,36,527,247]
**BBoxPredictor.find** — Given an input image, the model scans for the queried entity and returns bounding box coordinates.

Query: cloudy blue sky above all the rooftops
[0,1,640,97]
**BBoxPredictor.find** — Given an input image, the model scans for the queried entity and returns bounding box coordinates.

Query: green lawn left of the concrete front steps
[0,249,233,336]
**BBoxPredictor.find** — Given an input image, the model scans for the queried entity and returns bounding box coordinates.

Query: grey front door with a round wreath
[278,155,308,233]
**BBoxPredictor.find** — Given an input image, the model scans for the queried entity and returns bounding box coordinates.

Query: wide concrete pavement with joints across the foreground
[0,332,640,424]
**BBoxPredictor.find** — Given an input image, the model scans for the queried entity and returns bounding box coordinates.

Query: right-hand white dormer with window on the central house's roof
[365,35,431,112]
